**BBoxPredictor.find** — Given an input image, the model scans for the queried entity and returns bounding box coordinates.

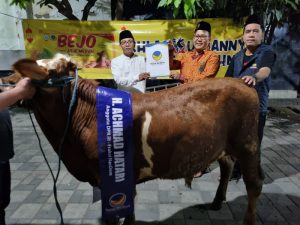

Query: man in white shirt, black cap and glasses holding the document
[111,30,150,93]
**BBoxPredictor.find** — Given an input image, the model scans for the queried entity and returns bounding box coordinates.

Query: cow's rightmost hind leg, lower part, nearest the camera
[240,151,264,225]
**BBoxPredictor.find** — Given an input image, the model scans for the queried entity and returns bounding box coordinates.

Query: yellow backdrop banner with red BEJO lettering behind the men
[23,18,243,79]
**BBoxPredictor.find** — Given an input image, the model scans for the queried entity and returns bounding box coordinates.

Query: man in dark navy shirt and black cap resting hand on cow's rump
[225,15,276,179]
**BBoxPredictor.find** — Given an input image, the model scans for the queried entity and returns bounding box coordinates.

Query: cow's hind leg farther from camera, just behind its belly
[210,156,233,210]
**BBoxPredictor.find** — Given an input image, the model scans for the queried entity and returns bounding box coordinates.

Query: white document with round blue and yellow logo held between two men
[146,42,170,77]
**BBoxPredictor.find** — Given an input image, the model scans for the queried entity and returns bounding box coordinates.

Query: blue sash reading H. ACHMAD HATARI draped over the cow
[96,87,134,219]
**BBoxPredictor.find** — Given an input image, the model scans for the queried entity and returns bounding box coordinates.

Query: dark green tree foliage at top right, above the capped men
[158,0,300,43]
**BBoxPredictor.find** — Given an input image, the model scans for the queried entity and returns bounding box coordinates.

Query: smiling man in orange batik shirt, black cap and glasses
[169,21,220,83]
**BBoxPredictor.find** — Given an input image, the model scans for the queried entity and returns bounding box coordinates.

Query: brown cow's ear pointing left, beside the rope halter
[13,59,48,80]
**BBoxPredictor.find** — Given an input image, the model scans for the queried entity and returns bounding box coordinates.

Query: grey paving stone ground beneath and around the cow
[6,110,300,225]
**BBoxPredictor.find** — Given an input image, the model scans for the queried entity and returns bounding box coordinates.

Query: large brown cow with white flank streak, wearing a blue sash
[4,55,263,225]
